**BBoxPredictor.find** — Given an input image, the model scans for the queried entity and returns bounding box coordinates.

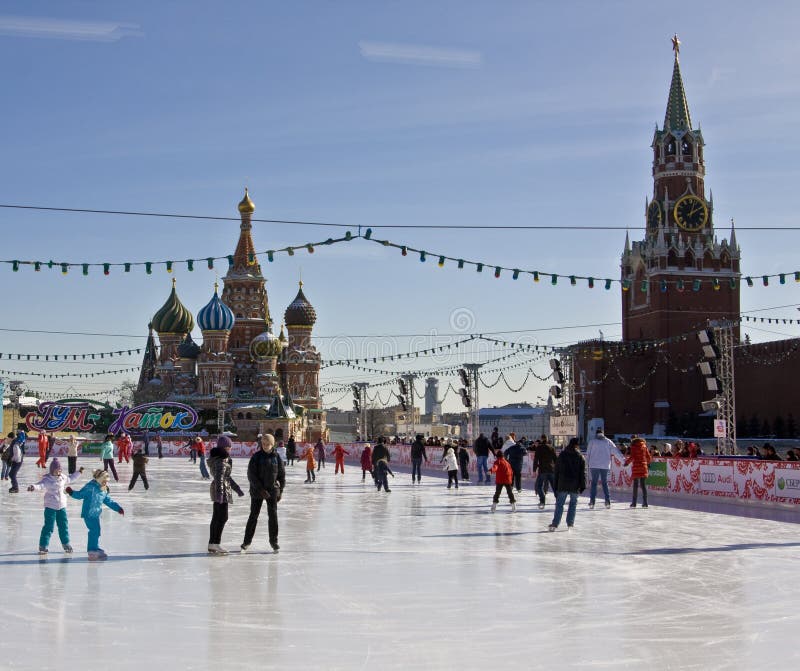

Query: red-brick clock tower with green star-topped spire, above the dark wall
[620,35,740,341]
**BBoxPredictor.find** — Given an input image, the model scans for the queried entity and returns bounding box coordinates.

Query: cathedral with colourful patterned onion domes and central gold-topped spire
[137,189,327,441]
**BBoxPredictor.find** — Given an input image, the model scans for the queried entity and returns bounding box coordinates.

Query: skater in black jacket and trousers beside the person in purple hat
[241,433,286,552]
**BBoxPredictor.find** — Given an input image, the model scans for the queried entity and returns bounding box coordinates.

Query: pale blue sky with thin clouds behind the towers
[0,0,800,411]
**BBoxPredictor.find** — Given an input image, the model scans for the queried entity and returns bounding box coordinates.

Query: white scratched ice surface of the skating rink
[0,456,800,671]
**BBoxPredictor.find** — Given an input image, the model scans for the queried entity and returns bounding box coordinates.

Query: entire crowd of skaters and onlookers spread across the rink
[6,428,800,560]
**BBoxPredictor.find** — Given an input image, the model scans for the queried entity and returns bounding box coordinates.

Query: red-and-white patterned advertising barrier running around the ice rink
[48,439,800,505]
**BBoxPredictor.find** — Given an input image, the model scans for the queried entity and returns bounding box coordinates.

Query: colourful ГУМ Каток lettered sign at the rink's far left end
[25,401,198,434]
